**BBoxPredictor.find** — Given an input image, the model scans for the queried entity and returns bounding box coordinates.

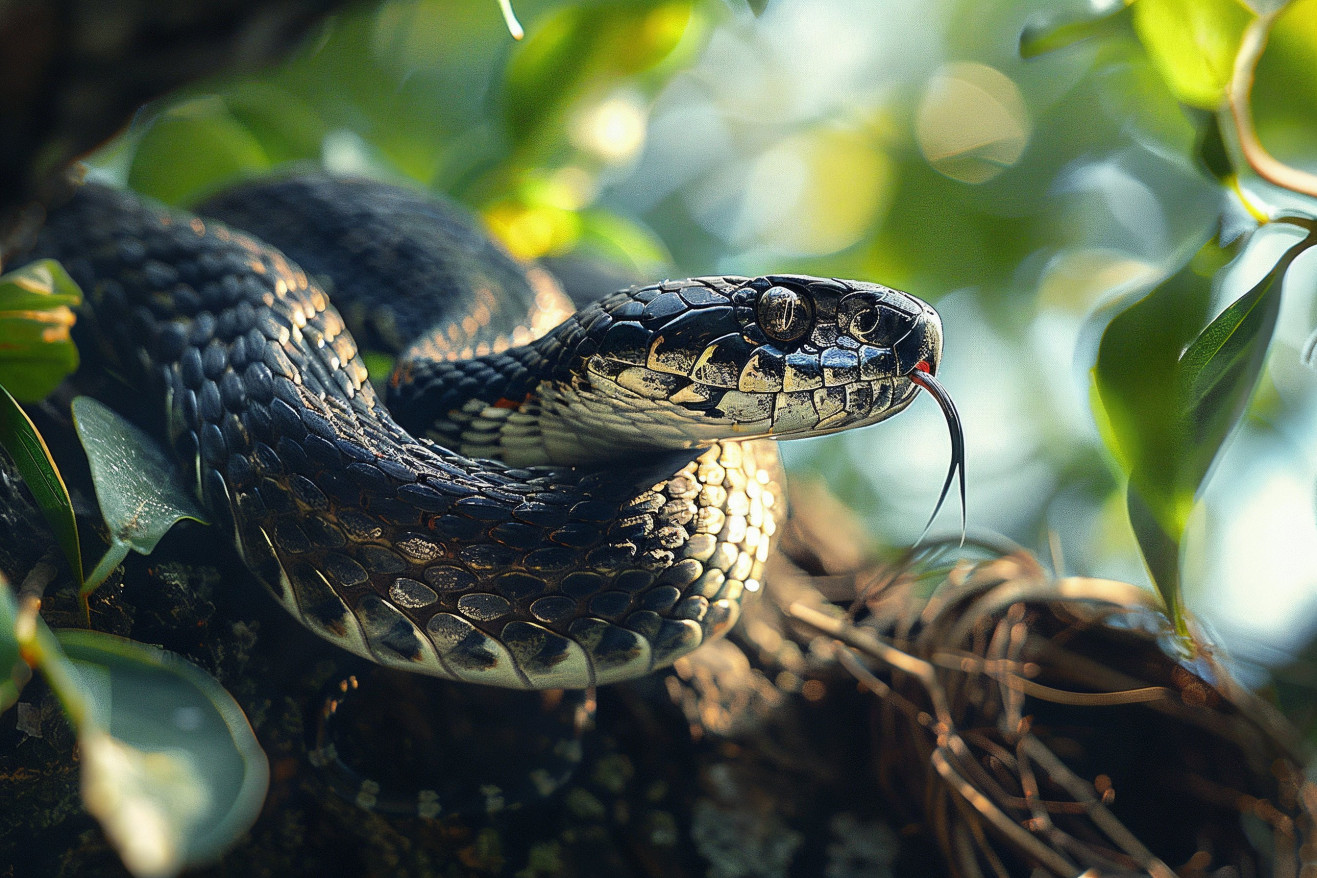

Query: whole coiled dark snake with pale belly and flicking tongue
[24,174,964,690]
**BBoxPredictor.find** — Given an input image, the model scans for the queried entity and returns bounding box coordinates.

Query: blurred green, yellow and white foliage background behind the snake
[92,0,1317,667]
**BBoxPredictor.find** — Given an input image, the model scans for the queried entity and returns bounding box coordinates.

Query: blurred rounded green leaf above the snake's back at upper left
[128,96,270,205]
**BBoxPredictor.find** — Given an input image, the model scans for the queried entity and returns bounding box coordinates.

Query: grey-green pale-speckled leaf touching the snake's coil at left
[72,396,207,592]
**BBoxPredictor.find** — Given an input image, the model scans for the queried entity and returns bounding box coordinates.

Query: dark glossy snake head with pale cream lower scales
[524,275,942,462]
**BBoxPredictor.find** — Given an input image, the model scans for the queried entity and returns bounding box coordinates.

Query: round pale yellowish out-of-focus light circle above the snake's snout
[915,62,1033,183]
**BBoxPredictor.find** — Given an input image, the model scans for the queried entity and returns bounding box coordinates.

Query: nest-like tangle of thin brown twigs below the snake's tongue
[782,521,1317,878]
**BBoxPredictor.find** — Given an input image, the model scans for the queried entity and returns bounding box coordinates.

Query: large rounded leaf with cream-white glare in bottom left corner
[58,631,269,877]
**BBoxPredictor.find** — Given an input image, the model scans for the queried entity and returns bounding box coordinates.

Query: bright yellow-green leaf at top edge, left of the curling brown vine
[1134,0,1254,109]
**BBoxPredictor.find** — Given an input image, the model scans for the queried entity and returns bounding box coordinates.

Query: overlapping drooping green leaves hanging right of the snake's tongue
[1093,223,1317,631]
